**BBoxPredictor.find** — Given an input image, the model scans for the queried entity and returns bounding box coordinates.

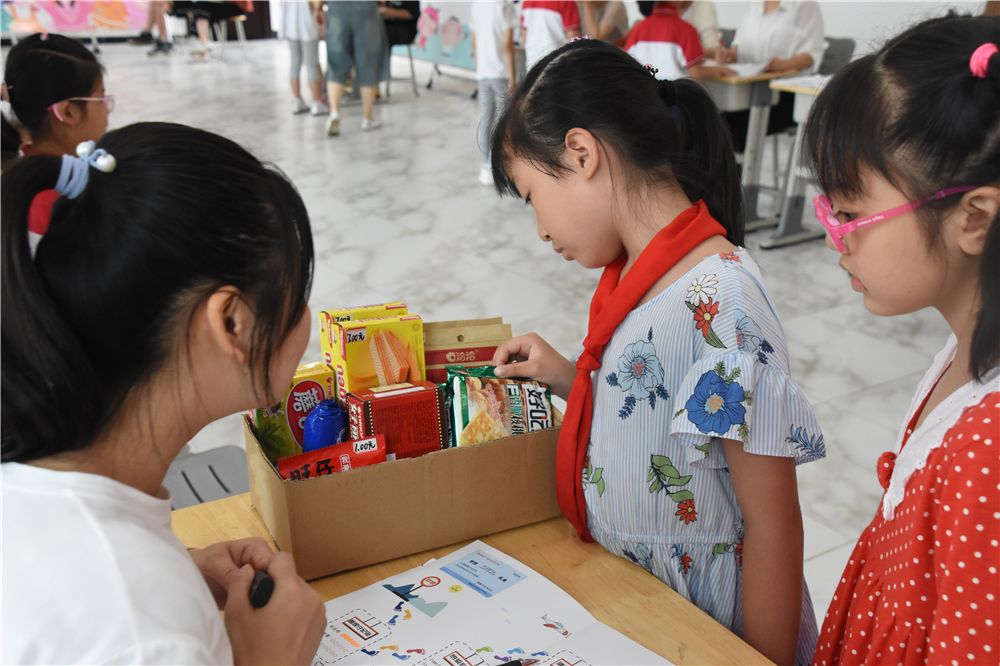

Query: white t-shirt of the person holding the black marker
[0,463,233,664]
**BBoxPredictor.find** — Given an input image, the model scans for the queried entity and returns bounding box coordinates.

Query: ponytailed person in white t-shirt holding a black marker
[0,123,326,664]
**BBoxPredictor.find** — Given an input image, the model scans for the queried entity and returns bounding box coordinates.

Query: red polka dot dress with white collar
[814,338,1000,665]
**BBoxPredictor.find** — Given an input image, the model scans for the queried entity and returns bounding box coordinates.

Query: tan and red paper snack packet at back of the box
[424,317,511,384]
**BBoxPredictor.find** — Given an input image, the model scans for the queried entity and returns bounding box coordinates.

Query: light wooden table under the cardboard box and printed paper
[173,494,770,664]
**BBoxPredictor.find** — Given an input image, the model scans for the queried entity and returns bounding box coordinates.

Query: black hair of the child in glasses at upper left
[4,34,104,141]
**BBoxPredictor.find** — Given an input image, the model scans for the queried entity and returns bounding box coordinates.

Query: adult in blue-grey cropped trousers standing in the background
[318,0,387,136]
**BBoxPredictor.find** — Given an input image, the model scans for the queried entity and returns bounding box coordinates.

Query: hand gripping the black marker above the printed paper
[225,553,326,664]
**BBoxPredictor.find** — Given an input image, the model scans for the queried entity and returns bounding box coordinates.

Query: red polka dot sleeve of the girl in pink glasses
[927,392,1000,664]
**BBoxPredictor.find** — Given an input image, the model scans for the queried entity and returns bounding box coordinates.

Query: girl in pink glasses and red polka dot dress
[806,16,1000,664]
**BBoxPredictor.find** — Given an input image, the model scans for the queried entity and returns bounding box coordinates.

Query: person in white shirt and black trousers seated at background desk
[717,0,826,153]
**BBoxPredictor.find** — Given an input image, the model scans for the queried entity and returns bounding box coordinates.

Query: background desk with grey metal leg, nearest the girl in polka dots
[760,75,830,250]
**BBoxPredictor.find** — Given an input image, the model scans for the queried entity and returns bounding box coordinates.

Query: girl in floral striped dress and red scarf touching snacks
[492,40,825,663]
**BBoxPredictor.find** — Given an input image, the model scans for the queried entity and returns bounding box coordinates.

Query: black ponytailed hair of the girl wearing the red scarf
[492,39,744,245]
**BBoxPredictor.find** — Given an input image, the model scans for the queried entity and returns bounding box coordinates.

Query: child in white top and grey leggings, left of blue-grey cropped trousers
[278,0,330,116]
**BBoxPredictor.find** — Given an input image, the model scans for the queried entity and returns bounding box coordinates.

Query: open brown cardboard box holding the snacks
[244,421,559,580]
